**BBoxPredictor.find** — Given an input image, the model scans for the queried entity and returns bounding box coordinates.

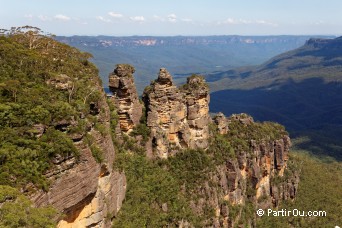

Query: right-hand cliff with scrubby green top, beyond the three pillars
[203,113,299,227]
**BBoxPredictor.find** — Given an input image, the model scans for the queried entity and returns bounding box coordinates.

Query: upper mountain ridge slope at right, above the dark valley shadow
[206,37,342,91]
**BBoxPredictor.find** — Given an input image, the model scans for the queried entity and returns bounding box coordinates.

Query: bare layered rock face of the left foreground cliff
[31,81,126,227]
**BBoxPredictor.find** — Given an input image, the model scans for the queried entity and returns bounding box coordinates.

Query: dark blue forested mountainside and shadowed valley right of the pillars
[207,37,342,159]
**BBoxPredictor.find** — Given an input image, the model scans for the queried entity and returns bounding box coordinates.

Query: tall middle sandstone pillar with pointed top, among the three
[143,68,190,158]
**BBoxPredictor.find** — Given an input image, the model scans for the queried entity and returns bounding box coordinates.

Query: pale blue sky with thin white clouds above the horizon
[0,0,342,36]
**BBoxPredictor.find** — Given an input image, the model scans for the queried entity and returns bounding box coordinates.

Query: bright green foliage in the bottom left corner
[0,185,58,228]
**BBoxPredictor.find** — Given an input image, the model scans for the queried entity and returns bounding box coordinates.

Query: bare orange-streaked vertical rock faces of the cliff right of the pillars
[187,113,299,227]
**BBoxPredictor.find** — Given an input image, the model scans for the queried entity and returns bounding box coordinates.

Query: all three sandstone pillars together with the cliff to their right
[110,64,299,227]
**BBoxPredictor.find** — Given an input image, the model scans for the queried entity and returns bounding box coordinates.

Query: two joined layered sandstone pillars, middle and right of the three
[143,68,209,158]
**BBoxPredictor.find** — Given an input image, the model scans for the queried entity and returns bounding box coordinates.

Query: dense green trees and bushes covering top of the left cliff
[0,26,101,190]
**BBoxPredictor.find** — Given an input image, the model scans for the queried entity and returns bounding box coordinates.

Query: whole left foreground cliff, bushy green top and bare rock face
[0,26,126,227]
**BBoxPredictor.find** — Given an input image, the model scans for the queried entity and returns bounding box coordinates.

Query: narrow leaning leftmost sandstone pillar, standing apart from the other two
[109,64,142,133]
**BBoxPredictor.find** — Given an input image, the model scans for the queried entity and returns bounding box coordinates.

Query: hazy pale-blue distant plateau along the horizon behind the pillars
[56,36,332,94]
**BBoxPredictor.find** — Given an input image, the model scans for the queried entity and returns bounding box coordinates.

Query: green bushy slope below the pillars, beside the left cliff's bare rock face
[113,151,196,227]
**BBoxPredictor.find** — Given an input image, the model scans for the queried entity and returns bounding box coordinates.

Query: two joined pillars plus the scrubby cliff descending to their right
[110,65,299,227]
